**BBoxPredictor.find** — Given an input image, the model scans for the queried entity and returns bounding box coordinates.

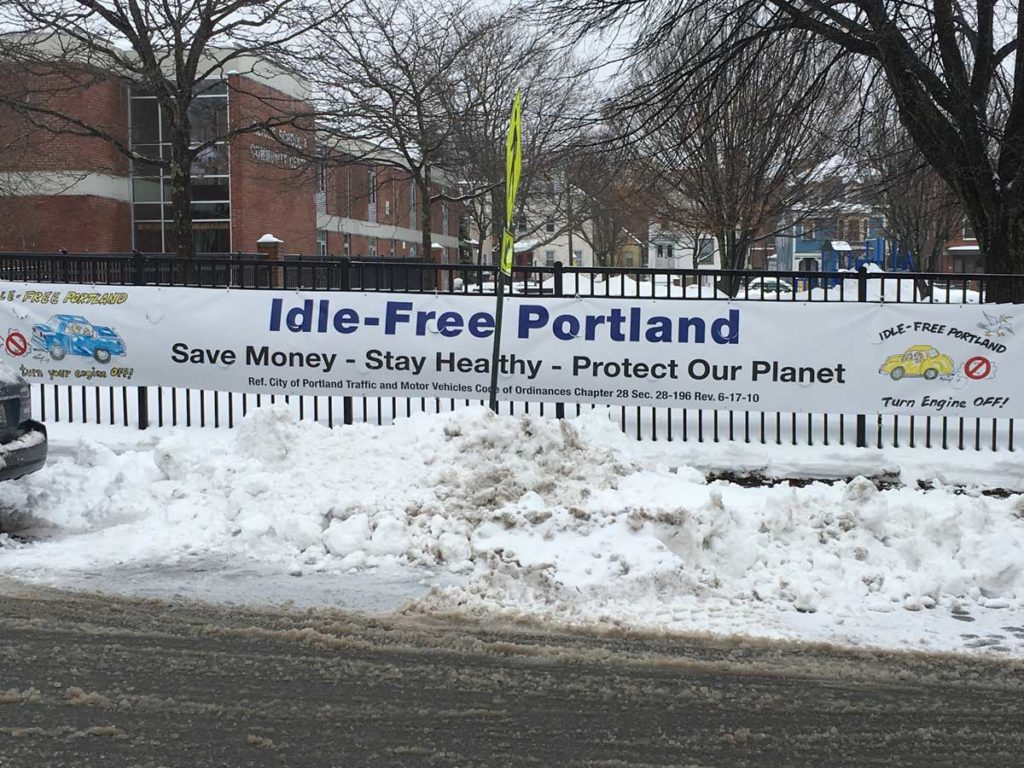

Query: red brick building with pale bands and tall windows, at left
[0,60,459,261]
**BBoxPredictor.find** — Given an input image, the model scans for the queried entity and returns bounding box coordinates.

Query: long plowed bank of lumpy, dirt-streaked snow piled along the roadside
[0,408,1024,643]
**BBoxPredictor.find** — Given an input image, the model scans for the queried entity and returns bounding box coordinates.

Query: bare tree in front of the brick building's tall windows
[0,0,327,257]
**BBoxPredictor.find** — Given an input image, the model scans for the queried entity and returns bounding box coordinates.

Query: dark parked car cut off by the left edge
[0,360,47,480]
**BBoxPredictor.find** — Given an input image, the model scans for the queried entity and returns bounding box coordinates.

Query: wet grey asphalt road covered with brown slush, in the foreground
[0,581,1024,768]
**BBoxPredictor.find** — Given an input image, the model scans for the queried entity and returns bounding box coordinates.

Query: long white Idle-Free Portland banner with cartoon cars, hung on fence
[0,283,1024,418]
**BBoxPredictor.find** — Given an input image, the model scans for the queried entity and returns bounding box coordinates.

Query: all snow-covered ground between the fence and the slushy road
[0,408,1024,656]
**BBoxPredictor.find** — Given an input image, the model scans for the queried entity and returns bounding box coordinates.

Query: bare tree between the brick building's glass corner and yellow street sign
[301,0,488,264]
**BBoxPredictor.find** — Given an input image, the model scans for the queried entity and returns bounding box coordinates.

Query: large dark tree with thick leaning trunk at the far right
[560,0,1024,301]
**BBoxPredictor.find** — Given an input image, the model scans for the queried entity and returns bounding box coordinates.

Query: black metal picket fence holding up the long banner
[0,253,1024,451]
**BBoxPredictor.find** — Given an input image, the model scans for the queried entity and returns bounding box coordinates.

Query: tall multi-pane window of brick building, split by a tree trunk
[128,81,231,253]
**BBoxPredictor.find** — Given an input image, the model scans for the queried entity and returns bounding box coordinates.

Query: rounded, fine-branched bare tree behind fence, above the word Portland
[634,28,849,269]
